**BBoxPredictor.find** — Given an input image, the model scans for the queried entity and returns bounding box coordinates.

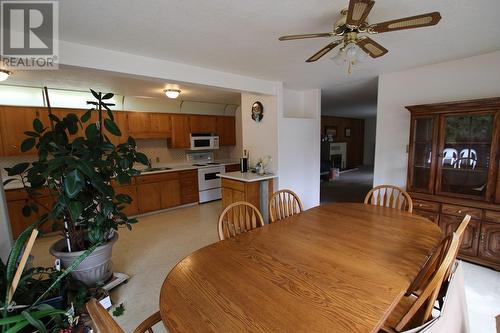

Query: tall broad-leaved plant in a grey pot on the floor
[6,88,148,285]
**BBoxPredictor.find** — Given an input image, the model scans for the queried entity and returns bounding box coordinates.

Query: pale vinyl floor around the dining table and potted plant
[33,201,500,333]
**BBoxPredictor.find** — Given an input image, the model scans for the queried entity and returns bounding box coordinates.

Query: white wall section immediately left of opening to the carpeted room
[278,89,321,209]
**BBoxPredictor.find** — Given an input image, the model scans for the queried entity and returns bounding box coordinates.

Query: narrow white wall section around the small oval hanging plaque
[241,93,278,172]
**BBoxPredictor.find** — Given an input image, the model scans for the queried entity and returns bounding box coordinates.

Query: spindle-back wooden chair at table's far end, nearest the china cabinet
[365,185,413,213]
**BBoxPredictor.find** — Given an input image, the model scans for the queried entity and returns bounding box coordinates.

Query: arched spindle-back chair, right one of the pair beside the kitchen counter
[217,201,264,240]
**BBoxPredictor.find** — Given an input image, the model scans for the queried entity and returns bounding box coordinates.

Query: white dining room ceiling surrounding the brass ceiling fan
[34,0,500,113]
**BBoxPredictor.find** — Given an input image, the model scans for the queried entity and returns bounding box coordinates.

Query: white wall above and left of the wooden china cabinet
[374,52,500,186]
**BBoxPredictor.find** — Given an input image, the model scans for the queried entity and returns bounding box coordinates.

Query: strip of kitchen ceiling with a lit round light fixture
[2,66,241,105]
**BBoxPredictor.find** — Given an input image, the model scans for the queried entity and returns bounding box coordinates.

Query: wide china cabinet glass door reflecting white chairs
[438,113,494,199]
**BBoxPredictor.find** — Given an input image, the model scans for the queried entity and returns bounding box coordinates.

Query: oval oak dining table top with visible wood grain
[160,203,442,333]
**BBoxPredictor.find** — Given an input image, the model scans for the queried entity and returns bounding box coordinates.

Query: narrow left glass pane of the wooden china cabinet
[410,117,435,192]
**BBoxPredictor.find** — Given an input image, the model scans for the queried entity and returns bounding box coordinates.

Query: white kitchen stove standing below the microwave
[187,152,226,203]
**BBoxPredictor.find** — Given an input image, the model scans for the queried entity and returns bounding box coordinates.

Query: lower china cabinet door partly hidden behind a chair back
[439,215,481,257]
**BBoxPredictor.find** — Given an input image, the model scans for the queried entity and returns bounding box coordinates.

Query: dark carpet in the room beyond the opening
[320,166,373,204]
